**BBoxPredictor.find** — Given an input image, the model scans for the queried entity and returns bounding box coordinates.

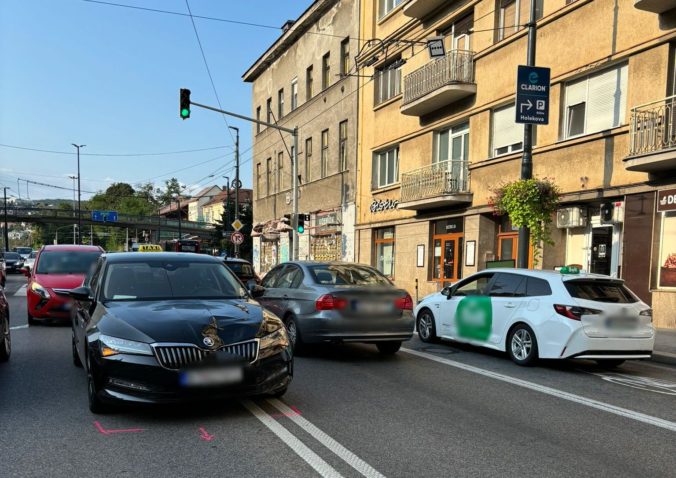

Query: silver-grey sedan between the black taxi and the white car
[252,261,414,354]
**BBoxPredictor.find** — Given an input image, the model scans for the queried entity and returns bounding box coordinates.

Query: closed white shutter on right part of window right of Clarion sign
[586,65,627,133]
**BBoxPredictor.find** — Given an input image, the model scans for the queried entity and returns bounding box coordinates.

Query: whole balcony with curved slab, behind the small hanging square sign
[401,50,476,116]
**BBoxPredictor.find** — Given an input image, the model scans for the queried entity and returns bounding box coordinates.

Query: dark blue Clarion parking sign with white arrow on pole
[516,65,550,124]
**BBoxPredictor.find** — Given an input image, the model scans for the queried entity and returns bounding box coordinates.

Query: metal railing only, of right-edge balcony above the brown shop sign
[629,95,676,156]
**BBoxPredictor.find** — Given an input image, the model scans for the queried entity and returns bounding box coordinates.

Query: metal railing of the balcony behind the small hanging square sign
[404,50,474,104]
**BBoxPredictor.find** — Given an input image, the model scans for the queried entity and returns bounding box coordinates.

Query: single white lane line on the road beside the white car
[401,348,676,432]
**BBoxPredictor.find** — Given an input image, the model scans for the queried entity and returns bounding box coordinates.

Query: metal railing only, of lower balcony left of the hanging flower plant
[401,160,469,202]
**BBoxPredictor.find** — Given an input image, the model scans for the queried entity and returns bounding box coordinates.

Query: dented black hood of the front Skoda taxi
[98,299,263,348]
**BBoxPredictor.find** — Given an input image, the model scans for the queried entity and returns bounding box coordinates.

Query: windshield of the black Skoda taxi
[103,260,247,301]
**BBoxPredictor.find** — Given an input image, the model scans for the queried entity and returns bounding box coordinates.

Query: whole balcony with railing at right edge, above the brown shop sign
[624,95,676,173]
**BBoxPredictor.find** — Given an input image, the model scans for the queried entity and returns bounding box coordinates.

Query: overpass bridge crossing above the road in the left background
[0,206,214,238]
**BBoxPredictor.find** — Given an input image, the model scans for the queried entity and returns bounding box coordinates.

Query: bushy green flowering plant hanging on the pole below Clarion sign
[490,178,560,247]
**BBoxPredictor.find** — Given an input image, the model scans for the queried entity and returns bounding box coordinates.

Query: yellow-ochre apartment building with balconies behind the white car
[356,0,676,327]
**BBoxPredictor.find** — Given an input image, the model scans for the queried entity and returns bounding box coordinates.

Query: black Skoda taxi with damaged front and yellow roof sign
[63,253,293,413]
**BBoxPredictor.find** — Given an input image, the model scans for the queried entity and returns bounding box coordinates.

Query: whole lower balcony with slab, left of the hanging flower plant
[399,160,472,210]
